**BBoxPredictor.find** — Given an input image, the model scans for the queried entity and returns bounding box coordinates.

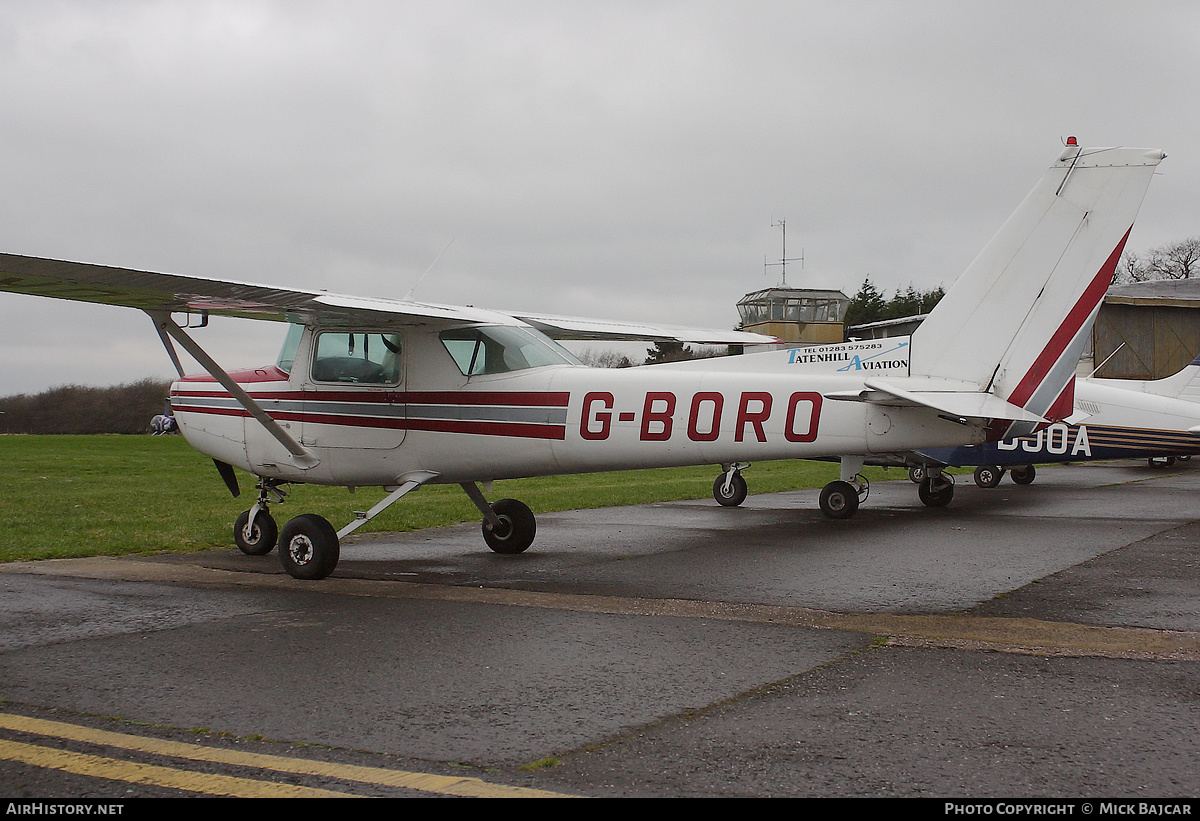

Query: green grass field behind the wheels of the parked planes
[0,436,905,562]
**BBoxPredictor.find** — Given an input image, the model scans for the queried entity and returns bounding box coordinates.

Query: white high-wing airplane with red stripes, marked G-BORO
[0,139,1165,579]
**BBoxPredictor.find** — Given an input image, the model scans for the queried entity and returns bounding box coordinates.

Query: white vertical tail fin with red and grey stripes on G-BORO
[910,144,1165,436]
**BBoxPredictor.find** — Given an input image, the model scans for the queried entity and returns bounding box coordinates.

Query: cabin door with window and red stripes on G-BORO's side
[300,330,406,448]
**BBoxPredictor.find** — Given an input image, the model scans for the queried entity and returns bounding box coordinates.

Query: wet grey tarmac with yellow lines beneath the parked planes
[0,462,1200,798]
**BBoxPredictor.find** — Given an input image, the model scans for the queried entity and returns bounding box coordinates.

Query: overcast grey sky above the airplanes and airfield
[0,0,1200,395]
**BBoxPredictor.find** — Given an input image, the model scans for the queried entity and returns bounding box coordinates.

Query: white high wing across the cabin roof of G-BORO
[0,248,776,344]
